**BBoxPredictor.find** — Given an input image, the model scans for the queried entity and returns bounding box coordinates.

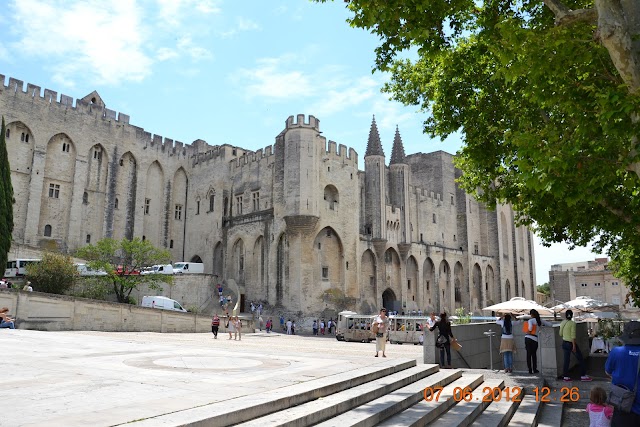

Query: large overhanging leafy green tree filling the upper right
[316,0,640,306]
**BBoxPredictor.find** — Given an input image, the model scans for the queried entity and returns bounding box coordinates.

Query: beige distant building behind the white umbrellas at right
[549,258,632,309]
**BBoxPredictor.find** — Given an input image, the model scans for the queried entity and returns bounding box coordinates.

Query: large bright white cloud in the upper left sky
[12,0,152,85]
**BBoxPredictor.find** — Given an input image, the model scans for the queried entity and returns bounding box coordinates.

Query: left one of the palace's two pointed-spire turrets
[364,116,386,239]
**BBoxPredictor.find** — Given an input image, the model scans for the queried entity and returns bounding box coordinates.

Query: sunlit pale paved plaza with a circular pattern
[0,329,422,427]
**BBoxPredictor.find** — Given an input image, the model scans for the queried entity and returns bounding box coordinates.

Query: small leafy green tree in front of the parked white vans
[76,237,173,302]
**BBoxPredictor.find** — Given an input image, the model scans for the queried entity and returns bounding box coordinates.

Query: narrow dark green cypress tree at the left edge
[0,117,13,268]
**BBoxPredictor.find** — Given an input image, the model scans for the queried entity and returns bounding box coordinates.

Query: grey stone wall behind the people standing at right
[424,323,589,378]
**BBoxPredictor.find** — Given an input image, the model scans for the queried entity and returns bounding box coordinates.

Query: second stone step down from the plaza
[235,365,444,427]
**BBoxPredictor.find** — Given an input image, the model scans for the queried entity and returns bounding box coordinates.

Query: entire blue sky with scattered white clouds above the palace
[0,0,595,284]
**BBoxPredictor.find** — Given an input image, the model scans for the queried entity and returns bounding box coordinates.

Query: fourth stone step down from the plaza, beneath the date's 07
[378,374,483,427]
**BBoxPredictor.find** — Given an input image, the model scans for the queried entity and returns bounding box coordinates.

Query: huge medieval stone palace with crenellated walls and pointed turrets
[0,76,536,313]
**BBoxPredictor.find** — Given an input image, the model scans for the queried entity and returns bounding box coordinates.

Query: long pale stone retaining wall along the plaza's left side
[0,289,253,333]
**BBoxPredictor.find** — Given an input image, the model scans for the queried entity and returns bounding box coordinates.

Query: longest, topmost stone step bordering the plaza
[136,359,416,427]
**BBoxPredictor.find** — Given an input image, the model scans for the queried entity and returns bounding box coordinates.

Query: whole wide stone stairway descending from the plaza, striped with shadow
[133,359,562,427]
